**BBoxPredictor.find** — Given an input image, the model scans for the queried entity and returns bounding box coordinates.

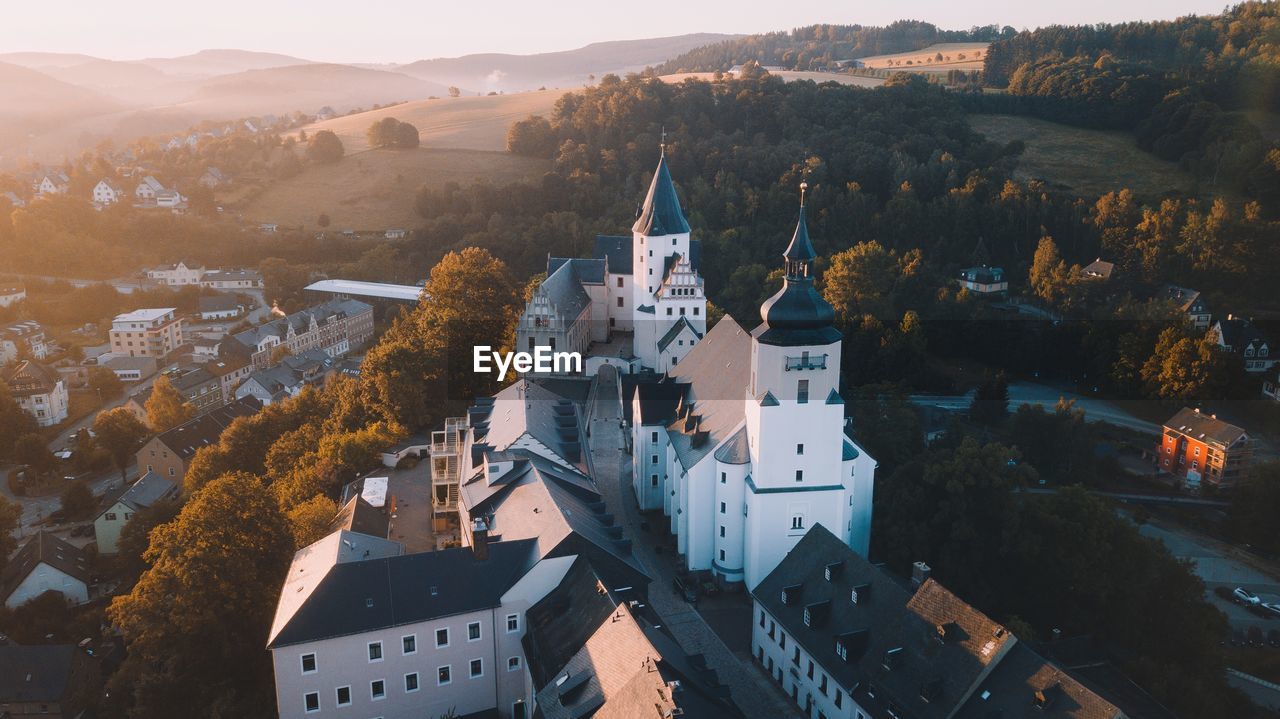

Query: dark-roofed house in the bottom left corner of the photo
[0,642,101,719]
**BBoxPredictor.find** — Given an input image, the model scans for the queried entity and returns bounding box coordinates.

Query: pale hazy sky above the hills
[0,0,1224,63]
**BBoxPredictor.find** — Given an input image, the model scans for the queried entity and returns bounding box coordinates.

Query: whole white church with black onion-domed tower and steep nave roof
[625,193,876,589]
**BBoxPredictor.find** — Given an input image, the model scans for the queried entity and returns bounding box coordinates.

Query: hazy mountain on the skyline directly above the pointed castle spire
[396,33,739,91]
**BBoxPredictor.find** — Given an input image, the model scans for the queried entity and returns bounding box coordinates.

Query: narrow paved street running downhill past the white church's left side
[590,367,803,719]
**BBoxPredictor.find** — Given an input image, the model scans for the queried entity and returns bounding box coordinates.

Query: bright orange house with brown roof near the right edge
[1157,407,1253,490]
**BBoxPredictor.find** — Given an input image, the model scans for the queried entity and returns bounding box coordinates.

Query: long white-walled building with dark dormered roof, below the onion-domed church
[751,525,1123,719]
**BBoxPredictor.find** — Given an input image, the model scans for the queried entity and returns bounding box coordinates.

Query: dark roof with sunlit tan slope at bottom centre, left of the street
[522,558,742,719]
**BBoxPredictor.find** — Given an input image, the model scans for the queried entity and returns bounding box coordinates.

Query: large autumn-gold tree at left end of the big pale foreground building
[108,472,293,718]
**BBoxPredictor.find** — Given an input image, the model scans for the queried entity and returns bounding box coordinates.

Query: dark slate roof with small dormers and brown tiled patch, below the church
[751,525,1016,719]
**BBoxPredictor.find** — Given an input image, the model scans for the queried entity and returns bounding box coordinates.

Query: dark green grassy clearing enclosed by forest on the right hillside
[969,115,1194,198]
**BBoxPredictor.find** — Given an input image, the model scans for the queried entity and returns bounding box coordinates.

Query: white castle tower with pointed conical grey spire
[631,142,707,371]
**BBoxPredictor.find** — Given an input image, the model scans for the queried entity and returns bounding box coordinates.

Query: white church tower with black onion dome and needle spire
[744,184,849,587]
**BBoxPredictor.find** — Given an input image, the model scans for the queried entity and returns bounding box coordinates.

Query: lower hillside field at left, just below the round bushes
[241,147,550,230]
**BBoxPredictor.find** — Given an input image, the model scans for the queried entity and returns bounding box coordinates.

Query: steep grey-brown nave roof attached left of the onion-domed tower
[660,316,751,470]
